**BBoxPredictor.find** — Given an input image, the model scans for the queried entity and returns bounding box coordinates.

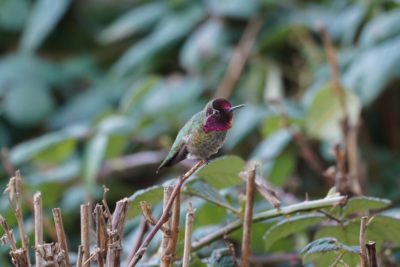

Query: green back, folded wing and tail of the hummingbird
[157,112,201,172]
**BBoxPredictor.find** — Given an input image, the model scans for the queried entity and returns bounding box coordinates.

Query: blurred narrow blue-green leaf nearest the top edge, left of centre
[98,3,166,44]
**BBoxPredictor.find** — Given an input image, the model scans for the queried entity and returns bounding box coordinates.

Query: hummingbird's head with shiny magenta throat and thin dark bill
[203,98,244,133]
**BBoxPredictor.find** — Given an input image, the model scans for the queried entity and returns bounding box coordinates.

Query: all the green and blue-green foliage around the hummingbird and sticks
[0,0,400,266]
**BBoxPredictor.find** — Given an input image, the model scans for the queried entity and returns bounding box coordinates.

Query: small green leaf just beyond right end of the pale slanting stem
[343,197,392,216]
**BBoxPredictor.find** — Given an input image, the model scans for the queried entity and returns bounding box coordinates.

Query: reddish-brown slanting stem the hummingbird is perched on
[127,160,204,267]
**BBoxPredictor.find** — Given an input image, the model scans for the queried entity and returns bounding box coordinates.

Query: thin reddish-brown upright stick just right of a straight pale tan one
[94,204,108,267]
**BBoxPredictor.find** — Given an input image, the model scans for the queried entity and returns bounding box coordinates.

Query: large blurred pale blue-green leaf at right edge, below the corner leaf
[343,37,400,105]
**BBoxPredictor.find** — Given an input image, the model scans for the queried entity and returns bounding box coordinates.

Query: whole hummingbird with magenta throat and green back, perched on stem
[157,98,244,172]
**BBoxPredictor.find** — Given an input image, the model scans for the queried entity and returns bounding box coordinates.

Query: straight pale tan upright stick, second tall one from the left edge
[33,192,44,266]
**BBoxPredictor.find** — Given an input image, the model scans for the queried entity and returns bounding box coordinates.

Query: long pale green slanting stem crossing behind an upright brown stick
[192,196,347,250]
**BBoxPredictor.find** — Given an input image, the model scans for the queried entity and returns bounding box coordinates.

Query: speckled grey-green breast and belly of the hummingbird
[186,129,226,159]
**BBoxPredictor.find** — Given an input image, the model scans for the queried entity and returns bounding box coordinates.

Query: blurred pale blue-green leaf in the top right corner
[360,9,400,47]
